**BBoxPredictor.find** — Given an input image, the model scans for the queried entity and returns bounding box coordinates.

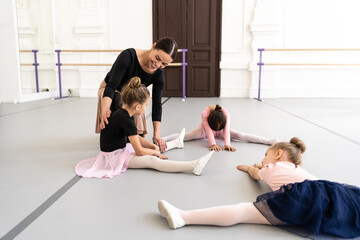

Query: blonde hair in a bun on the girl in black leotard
[120,77,150,106]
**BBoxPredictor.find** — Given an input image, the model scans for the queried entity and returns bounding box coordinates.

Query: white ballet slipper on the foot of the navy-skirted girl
[158,200,185,229]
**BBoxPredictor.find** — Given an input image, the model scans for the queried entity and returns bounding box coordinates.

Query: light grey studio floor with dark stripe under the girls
[0,98,360,240]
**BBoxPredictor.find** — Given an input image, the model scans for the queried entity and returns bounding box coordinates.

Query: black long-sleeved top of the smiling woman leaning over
[103,48,165,121]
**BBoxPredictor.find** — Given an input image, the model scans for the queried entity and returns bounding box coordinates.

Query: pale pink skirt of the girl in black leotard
[75,143,135,178]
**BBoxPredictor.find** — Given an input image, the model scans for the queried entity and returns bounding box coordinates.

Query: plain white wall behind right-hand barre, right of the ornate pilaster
[246,0,360,97]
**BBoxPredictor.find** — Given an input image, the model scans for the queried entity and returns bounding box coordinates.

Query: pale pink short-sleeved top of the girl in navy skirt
[259,161,318,191]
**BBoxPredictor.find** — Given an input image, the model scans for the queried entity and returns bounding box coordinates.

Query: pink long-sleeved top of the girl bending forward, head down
[201,107,231,146]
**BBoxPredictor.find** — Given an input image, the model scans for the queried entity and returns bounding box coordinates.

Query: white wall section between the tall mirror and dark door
[51,0,152,97]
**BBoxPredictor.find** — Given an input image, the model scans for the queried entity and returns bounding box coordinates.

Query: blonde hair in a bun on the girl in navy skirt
[270,137,306,165]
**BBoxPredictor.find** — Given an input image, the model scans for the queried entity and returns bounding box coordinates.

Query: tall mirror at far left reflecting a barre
[16,0,57,100]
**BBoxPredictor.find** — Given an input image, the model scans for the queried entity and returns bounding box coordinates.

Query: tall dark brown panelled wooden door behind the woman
[153,0,222,97]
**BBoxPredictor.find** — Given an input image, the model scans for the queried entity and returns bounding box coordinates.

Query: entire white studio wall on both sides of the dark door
[4,0,360,101]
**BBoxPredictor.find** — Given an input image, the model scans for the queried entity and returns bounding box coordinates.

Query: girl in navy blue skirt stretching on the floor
[158,138,360,238]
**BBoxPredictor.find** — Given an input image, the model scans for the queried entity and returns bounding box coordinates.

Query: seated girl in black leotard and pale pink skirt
[75,77,214,178]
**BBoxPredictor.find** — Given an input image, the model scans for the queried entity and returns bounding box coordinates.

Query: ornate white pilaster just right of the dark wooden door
[220,0,255,97]
